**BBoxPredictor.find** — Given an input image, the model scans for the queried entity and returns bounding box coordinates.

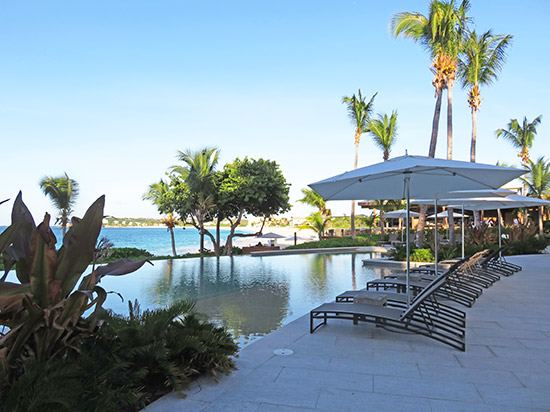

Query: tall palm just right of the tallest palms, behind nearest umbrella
[458,30,513,162]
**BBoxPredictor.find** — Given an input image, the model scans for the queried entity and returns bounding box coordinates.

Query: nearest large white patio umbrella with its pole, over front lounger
[309,155,526,306]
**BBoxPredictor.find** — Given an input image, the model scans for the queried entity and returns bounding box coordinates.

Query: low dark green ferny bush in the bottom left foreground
[0,302,237,412]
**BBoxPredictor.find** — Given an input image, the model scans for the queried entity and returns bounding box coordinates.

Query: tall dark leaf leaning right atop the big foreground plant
[55,196,105,296]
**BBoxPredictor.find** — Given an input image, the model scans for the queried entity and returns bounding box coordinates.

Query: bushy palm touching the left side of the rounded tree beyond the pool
[172,147,218,253]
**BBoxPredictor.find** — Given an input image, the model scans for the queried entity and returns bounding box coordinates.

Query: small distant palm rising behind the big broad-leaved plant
[40,173,79,237]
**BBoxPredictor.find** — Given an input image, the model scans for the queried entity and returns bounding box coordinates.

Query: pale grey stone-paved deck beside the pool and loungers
[145,254,550,412]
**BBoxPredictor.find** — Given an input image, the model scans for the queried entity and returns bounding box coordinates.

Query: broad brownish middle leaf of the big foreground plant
[28,213,59,308]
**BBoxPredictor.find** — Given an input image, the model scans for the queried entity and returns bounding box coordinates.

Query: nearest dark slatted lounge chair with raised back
[309,264,466,351]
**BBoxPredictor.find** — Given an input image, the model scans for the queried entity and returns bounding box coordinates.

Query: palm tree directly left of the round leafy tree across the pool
[172,147,218,253]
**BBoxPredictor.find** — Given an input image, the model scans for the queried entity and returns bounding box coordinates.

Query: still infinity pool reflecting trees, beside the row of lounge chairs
[102,253,396,347]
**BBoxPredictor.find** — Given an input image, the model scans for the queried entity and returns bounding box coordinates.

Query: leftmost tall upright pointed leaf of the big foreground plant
[9,192,36,283]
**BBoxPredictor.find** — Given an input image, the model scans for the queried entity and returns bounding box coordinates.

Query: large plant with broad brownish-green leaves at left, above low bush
[0,193,151,386]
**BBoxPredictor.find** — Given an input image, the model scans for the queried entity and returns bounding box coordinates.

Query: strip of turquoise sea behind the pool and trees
[0,226,250,256]
